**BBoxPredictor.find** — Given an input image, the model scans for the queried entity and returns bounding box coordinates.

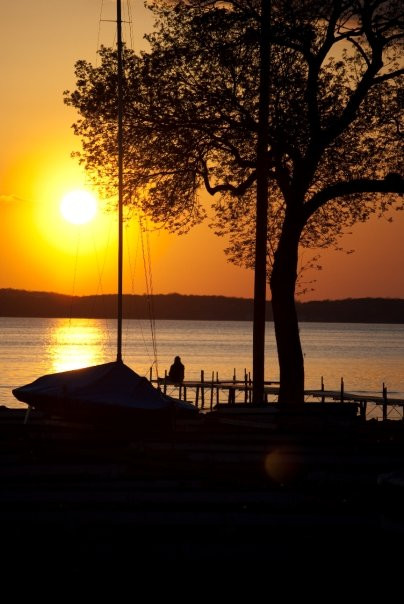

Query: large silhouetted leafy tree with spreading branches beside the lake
[66,0,403,403]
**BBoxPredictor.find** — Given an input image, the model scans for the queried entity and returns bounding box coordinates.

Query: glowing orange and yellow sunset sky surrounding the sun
[0,0,404,299]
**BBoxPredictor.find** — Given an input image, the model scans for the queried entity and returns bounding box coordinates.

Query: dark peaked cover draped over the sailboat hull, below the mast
[13,361,195,411]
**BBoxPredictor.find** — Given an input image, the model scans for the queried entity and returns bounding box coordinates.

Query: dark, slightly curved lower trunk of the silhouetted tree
[271,217,304,404]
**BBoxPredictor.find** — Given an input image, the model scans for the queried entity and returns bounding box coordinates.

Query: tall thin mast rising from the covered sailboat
[116,0,123,361]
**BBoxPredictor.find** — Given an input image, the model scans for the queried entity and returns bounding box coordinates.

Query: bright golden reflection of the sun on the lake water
[48,319,106,372]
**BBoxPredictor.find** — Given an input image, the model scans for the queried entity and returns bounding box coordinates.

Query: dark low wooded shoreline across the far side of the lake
[0,289,404,324]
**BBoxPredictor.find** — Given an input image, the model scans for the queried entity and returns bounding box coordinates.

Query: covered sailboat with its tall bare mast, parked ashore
[12,0,197,428]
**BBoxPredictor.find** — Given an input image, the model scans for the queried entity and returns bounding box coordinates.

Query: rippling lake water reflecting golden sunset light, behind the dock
[0,317,404,416]
